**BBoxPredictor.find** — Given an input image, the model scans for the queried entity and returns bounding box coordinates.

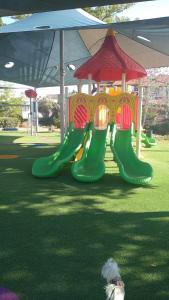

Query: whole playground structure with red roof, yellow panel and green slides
[32,30,153,185]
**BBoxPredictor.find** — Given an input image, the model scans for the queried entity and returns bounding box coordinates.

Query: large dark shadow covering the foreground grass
[0,198,169,300]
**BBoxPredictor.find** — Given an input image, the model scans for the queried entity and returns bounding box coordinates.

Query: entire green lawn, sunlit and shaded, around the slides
[0,132,169,300]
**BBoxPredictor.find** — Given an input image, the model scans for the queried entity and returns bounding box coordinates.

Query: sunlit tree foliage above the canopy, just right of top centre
[84,3,134,23]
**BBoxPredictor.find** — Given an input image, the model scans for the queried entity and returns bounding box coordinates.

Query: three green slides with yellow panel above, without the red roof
[32,93,152,184]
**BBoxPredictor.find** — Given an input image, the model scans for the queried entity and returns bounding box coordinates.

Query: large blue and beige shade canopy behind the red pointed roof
[0,9,169,87]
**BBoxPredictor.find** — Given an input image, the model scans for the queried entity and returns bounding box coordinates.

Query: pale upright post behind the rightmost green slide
[136,86,143,158]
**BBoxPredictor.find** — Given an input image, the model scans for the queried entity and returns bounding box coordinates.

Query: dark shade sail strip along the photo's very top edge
[0,0,153,16]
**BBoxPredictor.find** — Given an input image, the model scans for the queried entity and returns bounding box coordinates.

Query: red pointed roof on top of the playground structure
[74,29,147,82]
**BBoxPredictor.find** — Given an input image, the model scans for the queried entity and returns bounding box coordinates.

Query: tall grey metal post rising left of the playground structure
[60,30,65,143]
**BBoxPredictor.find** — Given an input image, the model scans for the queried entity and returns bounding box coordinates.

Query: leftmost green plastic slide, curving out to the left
[32,124,87,178]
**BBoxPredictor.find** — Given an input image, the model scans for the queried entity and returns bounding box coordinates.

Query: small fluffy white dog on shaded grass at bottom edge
[101,258,125,300]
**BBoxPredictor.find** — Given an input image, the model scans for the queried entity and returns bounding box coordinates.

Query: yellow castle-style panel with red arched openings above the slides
[69,88,138,129]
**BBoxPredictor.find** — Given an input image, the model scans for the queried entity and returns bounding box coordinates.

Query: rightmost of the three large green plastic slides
[111,129,153,185]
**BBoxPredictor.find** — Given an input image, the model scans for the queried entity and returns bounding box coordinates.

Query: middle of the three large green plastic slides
[71,124,109,182]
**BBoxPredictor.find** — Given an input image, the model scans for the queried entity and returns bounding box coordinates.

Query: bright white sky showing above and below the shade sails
[3,0,169,96]
